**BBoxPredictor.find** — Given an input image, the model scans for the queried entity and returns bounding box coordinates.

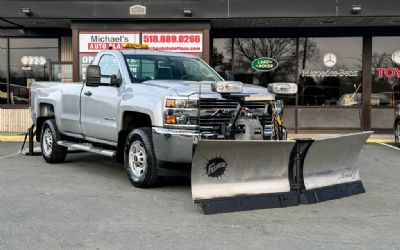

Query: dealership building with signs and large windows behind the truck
[0,0,400,133]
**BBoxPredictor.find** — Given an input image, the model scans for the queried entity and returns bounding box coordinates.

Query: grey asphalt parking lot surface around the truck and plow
[0,142,400,249]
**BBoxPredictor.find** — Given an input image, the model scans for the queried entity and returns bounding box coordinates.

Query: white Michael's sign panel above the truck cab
[79,32,140,53]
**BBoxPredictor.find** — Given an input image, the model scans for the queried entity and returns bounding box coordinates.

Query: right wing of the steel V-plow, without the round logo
[296,131,373,204]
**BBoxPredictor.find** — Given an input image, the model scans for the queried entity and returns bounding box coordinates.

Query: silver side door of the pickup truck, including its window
[81,54,121,142]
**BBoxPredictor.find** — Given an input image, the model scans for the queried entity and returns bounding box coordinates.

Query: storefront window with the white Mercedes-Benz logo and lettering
[298,37,362,106]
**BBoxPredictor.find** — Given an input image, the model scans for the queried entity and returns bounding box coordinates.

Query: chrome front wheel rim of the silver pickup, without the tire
[129,141,147,178]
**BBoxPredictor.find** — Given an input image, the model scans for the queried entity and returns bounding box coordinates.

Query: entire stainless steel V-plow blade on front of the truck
[191,132,372,214]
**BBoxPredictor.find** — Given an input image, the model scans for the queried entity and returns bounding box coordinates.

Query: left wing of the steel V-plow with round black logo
[191,140,299,214]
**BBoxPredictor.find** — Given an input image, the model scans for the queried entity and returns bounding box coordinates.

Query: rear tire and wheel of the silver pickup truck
[40,119,68,163]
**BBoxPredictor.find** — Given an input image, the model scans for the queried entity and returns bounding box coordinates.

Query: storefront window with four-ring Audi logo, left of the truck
[10,38,59,104]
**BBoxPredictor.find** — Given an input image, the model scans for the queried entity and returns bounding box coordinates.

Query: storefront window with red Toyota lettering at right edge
[371,37,400,106]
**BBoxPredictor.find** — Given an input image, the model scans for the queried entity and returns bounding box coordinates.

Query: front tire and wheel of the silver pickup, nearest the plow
[124,128,159,188]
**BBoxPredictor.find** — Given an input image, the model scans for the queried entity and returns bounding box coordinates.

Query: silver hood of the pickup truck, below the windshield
[142,80,274,98]
